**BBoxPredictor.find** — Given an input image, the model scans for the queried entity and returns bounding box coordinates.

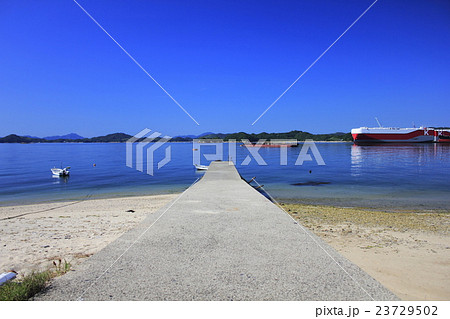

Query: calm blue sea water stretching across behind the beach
[0,143,450,209]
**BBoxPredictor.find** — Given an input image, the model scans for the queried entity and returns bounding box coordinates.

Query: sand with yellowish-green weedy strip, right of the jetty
[282,204,450,300]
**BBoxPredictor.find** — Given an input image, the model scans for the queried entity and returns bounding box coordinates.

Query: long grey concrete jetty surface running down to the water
[36,162,397,300]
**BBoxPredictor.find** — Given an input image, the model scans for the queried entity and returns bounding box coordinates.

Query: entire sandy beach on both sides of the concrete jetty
[0,194,450,300]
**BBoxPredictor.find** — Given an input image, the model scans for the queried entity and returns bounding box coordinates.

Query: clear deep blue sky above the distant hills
[0,0,450,137]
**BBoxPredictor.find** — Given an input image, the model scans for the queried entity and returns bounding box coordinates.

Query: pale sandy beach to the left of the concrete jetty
[0,194,177,275]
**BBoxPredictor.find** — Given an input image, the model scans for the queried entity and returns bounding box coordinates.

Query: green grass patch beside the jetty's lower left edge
[0,259,71,301]
